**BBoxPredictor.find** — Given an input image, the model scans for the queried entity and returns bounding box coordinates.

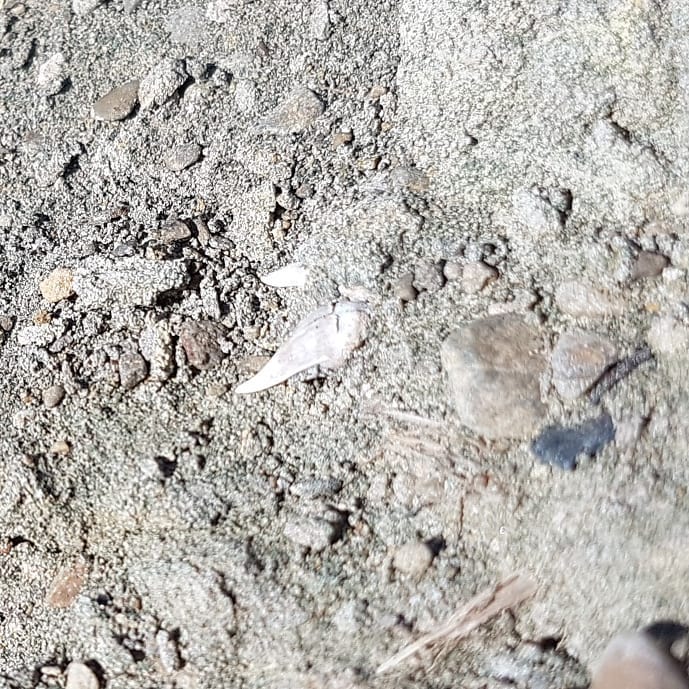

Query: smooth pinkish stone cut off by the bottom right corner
[591,632,689,689]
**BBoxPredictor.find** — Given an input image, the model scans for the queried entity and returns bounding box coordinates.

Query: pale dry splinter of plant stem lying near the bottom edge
[376,574,536,675]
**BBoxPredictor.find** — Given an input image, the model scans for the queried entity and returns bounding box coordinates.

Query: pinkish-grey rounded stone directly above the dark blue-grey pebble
[551,332,618,400]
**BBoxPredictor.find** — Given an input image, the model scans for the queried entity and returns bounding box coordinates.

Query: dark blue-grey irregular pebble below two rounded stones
[531,414,615,471]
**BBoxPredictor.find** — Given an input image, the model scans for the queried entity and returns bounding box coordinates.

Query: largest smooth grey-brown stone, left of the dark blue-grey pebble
[440,315,546,438]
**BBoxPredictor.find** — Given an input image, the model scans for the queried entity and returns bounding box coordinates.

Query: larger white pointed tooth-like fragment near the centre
[236,301,368,394]
